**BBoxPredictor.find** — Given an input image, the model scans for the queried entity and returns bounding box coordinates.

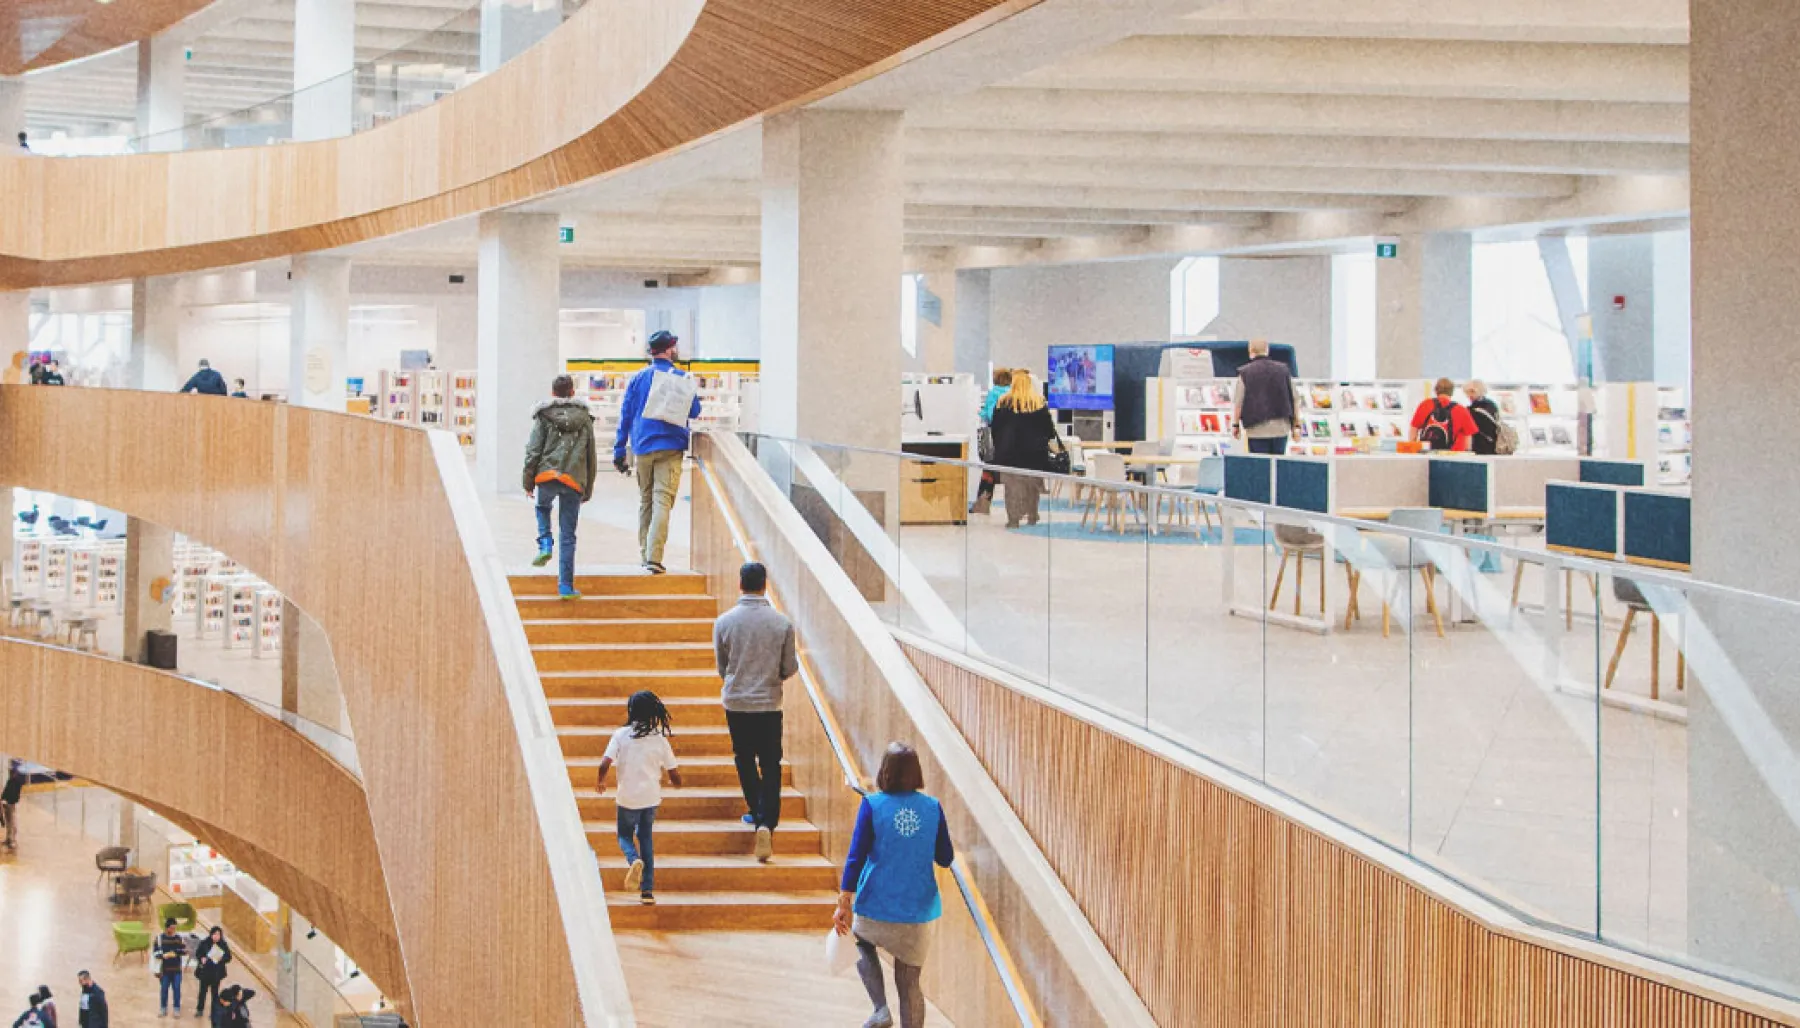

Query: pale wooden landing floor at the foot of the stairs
[616,931,950,1028]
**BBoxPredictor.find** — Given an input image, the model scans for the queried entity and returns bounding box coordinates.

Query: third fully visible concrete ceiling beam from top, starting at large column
[907,128,1688,175]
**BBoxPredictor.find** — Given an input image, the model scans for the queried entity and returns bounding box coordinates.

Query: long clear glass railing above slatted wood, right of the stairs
[740,436,1800,997]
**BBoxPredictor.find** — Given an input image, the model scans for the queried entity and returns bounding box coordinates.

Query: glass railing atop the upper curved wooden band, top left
[116,0,585,153]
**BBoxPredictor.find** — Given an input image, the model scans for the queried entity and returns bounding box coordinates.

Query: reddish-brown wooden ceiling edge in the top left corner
[0,0,214,76]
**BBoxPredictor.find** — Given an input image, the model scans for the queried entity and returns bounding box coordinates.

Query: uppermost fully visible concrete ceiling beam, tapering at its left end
[1008,36,1688,103]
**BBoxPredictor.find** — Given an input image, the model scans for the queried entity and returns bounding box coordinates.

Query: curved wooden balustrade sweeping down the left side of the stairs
[0,385,628,1028]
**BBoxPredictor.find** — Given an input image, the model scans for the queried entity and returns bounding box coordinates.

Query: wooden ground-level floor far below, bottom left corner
[0,803,301,1028]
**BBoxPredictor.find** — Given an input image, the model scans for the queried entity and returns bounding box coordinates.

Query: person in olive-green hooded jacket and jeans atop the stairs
[524,374,594,600]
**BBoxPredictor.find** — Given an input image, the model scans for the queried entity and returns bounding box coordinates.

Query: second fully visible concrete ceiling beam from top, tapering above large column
[909,88,1688,144]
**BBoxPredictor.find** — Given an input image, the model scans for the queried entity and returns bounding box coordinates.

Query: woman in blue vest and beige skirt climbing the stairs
[832,742,956,1028]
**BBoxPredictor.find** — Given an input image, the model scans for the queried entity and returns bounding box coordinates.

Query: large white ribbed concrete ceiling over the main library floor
[351,0,1688,272]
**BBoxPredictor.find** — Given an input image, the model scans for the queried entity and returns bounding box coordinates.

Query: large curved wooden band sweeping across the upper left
[0,0,1040,290]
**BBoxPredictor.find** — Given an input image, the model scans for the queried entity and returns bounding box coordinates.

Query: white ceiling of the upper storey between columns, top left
[25,0,580,135]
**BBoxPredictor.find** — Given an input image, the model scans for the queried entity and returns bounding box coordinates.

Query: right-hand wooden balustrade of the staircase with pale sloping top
[691,437,1130,1024]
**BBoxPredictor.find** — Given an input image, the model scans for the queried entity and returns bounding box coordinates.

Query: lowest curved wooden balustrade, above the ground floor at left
[0,639,409,1008]
